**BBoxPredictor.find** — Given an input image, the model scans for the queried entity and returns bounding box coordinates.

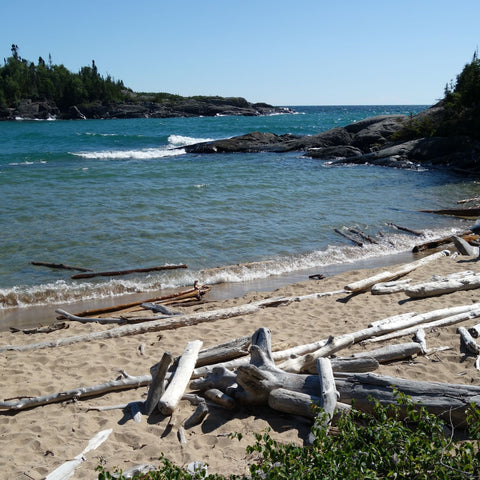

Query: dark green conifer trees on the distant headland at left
[0,45,125,109]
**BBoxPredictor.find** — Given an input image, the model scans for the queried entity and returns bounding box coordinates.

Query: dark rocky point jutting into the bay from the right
[185,104,480,173]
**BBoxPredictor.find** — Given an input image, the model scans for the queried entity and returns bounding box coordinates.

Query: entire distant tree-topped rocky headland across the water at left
[0,45,291,120]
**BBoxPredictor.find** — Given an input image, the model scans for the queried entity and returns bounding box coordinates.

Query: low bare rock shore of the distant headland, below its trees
[0,97,293,120]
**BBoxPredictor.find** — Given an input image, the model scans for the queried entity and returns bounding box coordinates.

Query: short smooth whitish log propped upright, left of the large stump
[158,340,203,415]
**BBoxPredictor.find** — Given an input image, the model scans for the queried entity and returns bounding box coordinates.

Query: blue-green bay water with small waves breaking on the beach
[0,106,478,308]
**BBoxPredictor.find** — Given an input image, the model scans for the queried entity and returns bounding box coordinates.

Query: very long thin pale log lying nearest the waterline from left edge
[0,290,345,353]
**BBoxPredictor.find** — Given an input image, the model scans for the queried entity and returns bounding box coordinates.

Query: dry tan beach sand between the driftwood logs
[0,253,480,480]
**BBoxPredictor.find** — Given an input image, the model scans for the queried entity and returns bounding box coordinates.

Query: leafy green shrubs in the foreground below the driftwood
[98,394,480,480]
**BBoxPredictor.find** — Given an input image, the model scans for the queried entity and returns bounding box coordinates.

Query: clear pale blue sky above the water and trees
[0,0,480,105]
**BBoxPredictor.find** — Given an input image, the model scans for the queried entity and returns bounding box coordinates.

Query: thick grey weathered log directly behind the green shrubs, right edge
[335,373,480,427]
